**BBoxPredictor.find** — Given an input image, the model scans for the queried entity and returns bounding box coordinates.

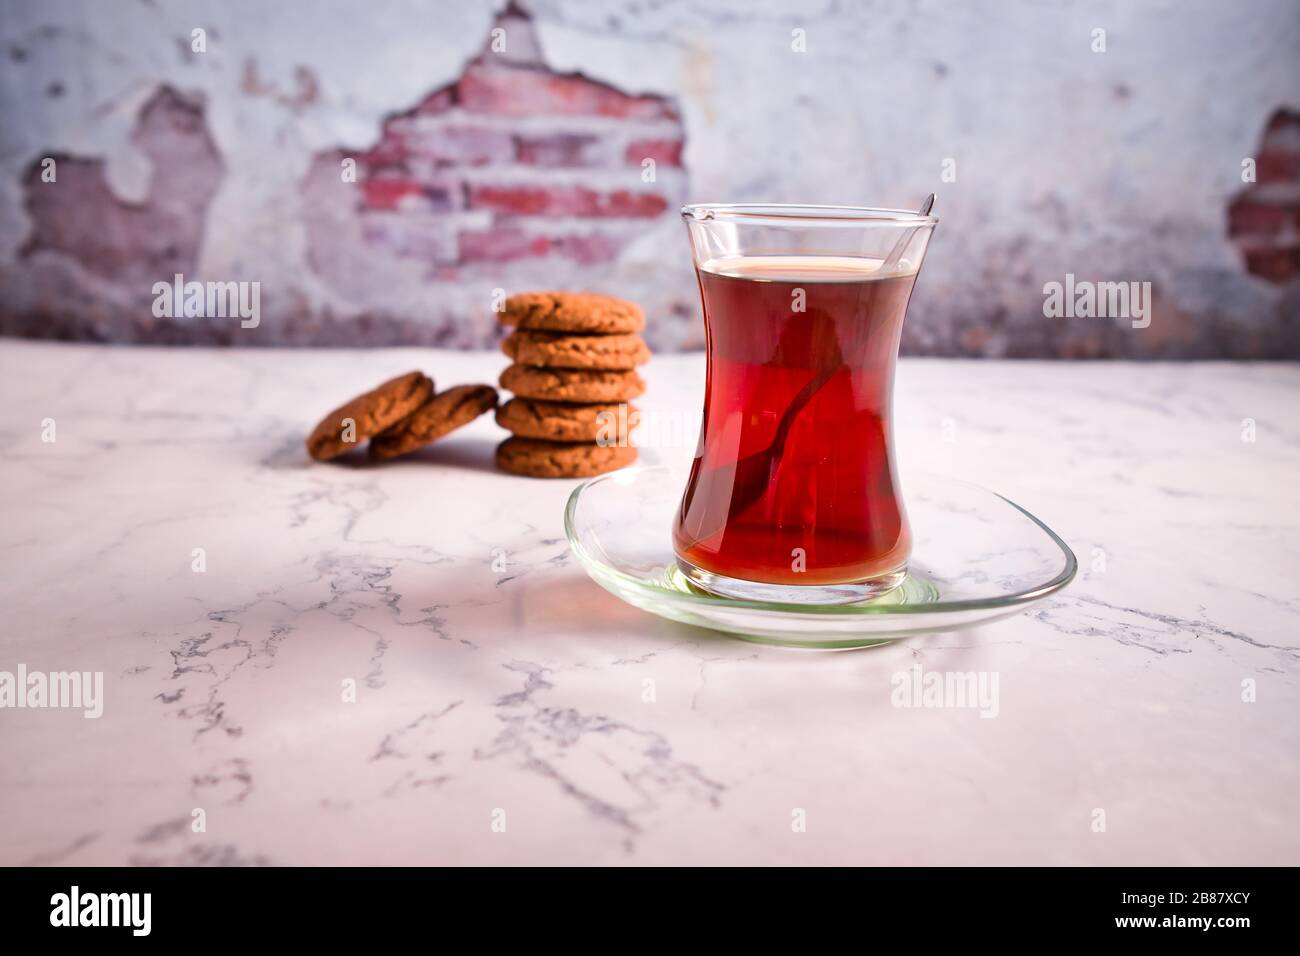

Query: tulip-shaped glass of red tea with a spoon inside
[673,204,937,605]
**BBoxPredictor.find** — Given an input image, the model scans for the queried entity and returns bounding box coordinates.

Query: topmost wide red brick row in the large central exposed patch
[456,64,676,120]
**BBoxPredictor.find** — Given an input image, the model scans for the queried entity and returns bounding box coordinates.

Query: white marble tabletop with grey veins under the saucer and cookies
[0,341,1300,865]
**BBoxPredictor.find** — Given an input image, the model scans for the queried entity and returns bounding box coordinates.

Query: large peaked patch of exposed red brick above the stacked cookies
[297,7,685,302]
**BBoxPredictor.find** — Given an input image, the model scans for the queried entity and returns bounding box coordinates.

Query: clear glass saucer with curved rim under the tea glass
[564,466,1078,648]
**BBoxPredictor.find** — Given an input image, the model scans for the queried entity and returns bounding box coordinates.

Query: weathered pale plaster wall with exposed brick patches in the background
[0,0,1300,358]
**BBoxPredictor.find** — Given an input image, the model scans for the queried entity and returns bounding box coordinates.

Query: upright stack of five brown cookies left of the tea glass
[497,293,650,477]
